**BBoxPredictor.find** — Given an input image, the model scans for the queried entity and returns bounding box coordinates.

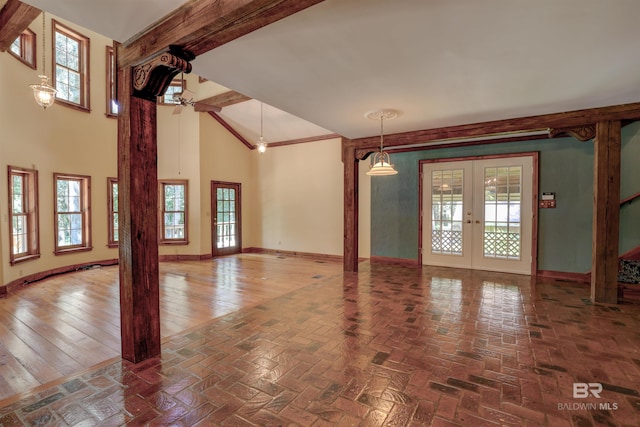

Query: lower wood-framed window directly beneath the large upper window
[53,173,91,254]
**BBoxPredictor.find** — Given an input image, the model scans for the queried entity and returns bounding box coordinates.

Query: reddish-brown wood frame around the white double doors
[418,151,539,276]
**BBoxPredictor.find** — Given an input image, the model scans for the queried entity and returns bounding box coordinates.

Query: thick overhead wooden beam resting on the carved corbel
[118,0,323,66]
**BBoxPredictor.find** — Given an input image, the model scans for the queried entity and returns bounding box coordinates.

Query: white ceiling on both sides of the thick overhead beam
[24,0,640,144]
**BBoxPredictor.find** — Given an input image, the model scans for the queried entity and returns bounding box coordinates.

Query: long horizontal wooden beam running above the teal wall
[353,103,640,150]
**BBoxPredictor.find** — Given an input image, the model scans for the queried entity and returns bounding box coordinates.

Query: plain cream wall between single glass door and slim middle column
[255,139,343,255]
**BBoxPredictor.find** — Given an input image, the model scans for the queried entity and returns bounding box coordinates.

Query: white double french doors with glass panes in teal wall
[421,156,534,274]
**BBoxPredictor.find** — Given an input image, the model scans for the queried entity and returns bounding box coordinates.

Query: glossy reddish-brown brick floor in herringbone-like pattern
[0,263,640,427]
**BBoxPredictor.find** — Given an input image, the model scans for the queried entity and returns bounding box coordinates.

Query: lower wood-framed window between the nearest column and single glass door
[159,180,189,245]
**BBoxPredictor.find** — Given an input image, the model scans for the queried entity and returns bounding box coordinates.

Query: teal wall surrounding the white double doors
[371,123,640,273]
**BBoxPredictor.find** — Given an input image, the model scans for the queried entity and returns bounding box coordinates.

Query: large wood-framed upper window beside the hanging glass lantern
[52,20,89,110]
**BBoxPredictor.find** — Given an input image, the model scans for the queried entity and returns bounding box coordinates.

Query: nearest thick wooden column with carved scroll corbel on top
[118,48,191,363]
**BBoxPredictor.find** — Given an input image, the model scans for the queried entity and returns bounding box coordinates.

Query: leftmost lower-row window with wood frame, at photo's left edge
[9,166,40,265]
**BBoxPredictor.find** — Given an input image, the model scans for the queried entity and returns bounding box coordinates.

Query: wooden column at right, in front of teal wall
[591,121,621,304]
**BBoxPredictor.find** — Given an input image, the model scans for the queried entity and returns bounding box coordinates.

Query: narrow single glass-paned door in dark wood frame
[211,181,242,257]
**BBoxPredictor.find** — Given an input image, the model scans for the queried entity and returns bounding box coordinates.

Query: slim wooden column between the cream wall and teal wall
[342,138,358,272]
